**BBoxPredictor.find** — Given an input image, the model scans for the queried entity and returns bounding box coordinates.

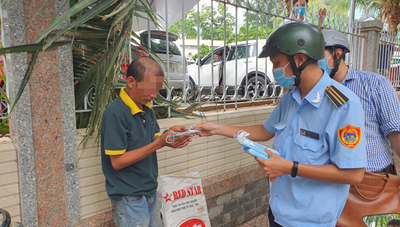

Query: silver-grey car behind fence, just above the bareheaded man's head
[122,30,194,96]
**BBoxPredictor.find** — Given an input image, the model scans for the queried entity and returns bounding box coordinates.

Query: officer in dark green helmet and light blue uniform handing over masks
[193,22,366,227]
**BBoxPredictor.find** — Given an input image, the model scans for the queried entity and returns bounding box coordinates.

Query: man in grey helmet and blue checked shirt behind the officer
[318,30,400,174]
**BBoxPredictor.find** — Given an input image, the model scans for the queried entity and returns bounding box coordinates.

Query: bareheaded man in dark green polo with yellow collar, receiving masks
[101,57,191,227]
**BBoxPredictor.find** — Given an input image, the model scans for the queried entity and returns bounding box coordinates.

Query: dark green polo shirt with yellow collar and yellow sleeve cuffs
[101,88,160,200]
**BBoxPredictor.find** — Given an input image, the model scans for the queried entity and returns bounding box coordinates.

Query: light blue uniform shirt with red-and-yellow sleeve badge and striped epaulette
[263,73,366,227]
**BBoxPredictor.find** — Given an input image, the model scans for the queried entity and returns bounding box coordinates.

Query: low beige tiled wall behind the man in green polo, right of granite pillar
[78,107,273,219]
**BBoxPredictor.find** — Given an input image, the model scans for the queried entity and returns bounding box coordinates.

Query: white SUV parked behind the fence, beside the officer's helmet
[188,40,280,97]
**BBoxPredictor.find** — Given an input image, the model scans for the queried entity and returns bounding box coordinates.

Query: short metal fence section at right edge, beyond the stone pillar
[377,29,400,88]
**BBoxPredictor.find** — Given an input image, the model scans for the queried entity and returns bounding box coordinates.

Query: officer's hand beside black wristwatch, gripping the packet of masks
[255,148,293,181]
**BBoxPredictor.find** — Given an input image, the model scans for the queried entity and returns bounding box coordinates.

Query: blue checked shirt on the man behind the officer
[342,66,400,172]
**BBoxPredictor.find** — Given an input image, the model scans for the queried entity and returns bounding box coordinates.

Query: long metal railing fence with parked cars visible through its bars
[2,0,378,120]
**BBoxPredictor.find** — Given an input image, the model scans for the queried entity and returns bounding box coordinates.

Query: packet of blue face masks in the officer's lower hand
[234,131,279,159]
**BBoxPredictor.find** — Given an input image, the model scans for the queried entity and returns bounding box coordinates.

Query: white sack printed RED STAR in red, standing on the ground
[157,172,211,227]
